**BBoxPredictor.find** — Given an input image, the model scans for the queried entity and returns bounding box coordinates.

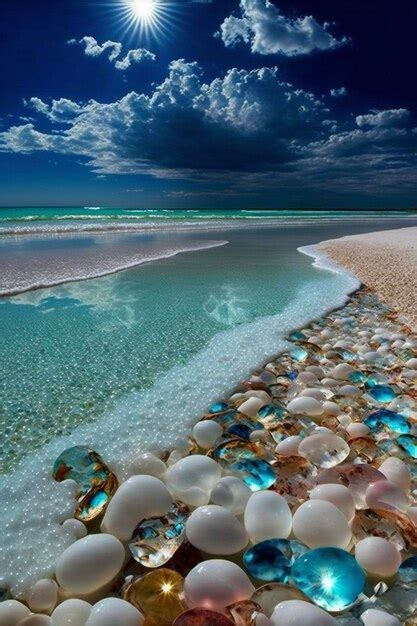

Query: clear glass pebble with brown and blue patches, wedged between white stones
[129,504,189,568]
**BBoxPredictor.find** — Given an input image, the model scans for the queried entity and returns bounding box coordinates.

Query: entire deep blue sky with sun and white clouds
[0,0,417,209]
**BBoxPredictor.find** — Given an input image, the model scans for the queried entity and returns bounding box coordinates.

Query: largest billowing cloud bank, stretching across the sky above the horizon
[0,59,417,193]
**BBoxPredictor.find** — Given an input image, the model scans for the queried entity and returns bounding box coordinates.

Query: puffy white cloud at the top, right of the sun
[216,0,348,56]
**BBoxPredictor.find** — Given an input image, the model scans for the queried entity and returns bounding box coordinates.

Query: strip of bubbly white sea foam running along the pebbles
[0,244,359,597]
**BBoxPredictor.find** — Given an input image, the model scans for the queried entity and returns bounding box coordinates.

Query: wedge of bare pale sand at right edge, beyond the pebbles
[320,227,417,330]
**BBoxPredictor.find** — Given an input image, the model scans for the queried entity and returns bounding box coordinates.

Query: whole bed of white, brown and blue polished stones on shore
[0,291,417,626]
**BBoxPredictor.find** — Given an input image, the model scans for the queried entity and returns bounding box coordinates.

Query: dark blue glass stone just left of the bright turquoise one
[243,539,308,584]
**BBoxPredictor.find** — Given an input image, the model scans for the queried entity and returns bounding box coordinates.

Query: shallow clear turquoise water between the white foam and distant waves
[0,214,414,472]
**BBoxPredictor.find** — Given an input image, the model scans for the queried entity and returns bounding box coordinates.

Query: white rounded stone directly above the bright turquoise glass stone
[292,500,352,548]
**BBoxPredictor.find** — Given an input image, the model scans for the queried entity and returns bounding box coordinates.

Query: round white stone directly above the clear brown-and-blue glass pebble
[166,454,222,506]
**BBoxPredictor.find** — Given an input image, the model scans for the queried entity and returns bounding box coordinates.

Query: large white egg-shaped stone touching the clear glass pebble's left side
[101,476,173,541]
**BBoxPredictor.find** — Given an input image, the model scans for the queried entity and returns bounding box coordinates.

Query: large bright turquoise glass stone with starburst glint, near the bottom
[291,548,366,612]
